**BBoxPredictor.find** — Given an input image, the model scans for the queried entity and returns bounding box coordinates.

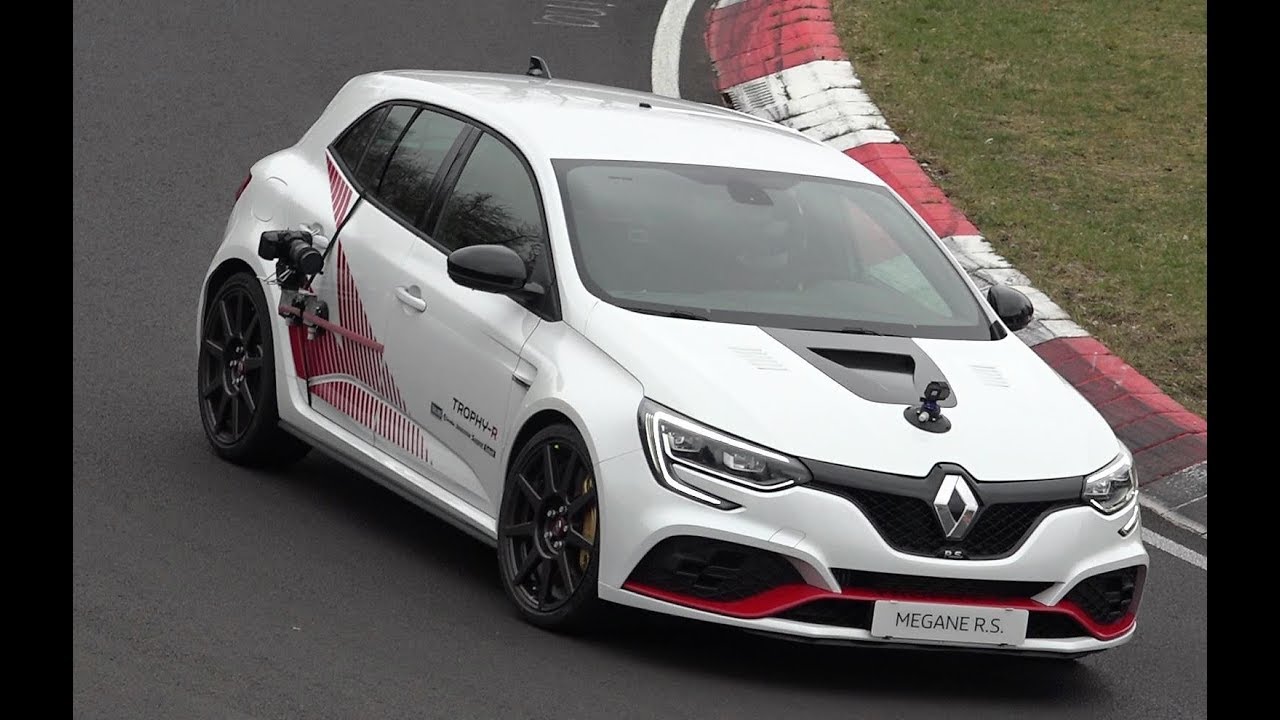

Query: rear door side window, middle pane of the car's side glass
[378,110,466,224]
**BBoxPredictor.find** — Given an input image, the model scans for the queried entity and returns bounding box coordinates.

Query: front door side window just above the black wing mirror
[435,133,549,283]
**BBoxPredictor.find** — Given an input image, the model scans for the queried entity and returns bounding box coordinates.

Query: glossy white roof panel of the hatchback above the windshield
[353,70,883,184]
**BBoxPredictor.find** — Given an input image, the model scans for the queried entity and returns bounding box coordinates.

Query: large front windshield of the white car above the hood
[554,160,991,340]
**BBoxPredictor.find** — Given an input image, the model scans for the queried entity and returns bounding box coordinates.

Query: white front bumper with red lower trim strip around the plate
[598,451,1148,655]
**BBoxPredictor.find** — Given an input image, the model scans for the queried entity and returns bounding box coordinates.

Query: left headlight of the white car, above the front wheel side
[640,400,809,510]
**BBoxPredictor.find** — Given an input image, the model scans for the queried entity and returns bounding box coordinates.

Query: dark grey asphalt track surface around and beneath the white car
[73,0,1207,720]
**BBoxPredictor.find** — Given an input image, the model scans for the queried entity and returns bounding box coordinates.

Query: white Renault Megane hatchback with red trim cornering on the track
[197,61,1148,657]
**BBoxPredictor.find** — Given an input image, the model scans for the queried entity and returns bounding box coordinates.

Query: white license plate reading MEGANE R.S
[872,600,1028,646]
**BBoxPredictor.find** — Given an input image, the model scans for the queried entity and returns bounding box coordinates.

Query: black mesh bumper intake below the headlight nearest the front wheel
[627,536,804,602]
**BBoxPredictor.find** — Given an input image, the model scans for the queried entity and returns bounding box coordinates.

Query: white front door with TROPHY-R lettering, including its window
[376,129,554,514]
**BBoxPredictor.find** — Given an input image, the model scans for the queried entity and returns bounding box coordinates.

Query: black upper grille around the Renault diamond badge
[810,482,1076,560]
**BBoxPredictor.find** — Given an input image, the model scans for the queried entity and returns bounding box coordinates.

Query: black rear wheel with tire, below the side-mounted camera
[196,273,310,468]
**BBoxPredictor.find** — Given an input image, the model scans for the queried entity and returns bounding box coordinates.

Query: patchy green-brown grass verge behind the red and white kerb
[832,0,1208,419]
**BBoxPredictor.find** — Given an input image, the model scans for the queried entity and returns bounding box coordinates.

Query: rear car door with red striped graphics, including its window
[296,102,466,448]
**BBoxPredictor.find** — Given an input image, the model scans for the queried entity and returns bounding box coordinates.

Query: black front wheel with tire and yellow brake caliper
[498,424,604,633]
